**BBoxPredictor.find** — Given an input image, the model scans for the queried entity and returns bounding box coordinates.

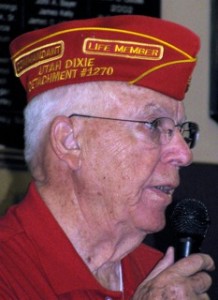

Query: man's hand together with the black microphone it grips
[132,199,214,300]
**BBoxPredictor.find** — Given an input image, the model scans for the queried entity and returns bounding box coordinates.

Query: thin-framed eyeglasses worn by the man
[68,113,199,149]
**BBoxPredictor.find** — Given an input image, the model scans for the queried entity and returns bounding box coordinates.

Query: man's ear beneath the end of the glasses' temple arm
[50,116,80,169]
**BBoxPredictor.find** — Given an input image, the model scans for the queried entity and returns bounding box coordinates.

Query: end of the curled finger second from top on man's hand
[190,272,212,295]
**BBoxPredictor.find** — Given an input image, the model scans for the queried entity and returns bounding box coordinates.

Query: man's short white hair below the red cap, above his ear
[24,82,130,168]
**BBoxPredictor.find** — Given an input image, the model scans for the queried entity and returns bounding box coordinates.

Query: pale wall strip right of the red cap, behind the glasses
[162,0,218,163]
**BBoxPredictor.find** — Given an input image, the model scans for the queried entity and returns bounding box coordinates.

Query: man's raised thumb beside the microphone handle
[144,247,174,282]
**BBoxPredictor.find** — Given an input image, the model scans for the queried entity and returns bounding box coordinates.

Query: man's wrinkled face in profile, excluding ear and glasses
[75,86,192,240]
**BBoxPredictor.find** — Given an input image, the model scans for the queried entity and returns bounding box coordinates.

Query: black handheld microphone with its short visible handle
[170,199,210,261]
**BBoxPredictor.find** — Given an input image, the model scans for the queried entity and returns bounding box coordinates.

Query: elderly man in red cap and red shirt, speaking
[0,16,214,300]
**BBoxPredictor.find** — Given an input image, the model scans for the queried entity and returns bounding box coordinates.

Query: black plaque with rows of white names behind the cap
[0,0,160,168]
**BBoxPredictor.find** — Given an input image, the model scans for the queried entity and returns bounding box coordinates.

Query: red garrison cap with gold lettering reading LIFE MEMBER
[10,15,200,100]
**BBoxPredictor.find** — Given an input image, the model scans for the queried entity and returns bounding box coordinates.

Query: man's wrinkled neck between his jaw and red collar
[39,182,142,290]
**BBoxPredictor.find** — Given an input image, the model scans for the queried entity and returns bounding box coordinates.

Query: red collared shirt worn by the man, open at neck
[0,183,162,300]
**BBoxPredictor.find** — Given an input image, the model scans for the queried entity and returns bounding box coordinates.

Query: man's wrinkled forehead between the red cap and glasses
[85,82,185,117]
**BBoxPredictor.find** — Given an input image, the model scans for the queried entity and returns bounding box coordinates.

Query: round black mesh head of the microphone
[170,199,210,240]
